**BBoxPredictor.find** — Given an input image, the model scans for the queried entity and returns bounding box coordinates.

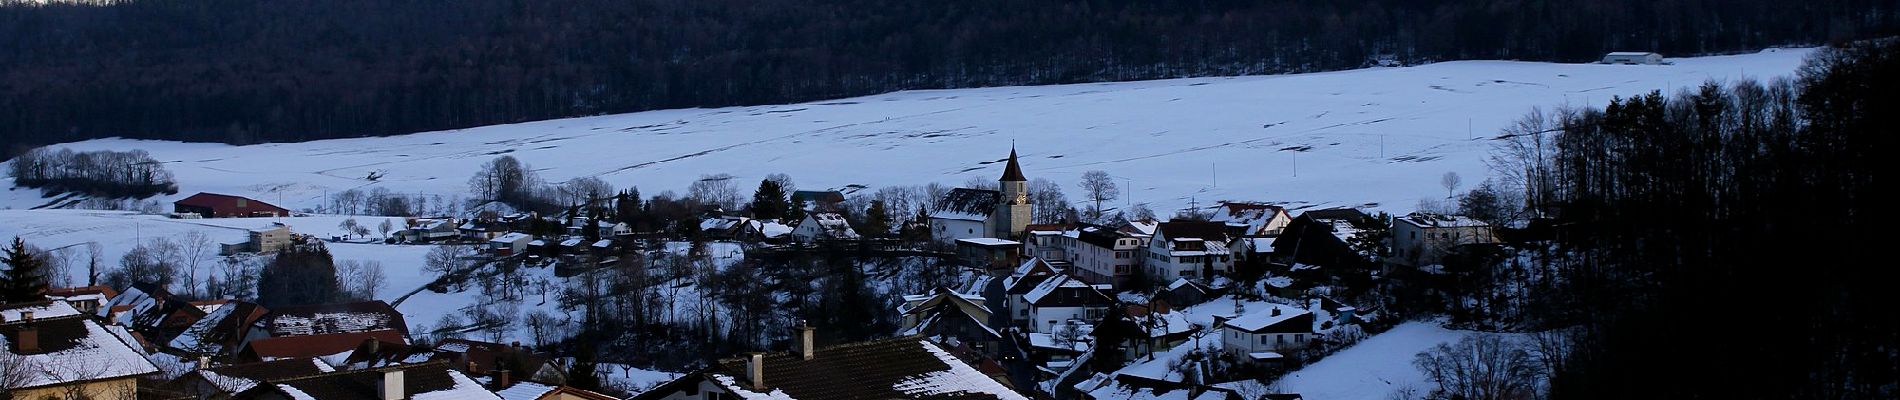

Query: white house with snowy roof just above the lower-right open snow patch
[1220,303,1319,362]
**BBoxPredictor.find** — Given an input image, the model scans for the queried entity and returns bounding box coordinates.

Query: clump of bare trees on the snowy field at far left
[8,148,179,199]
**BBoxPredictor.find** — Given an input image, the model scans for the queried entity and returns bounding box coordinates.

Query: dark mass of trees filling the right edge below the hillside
[1499,40,1900,398]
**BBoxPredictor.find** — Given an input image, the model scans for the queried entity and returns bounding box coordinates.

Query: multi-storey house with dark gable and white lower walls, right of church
[1146,220,1233,282]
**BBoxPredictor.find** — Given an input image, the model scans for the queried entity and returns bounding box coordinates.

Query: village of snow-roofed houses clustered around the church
[0,150,1505,400]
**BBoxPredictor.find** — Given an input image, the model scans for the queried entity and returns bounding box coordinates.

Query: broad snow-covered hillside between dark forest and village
[0,49,1809,214]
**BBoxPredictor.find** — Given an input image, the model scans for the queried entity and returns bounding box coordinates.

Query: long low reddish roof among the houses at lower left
[257,300,409,337]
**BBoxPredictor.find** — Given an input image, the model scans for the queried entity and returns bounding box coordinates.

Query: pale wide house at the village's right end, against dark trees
[1385,212,1497,267]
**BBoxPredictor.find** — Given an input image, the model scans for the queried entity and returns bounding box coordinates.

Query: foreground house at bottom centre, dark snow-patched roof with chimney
[633,328,1028,400]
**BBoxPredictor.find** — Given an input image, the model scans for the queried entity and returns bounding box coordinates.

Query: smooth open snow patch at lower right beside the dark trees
[1277,320,1474,400]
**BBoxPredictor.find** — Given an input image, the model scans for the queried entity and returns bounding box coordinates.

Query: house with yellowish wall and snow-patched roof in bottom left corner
[0,301,158,400]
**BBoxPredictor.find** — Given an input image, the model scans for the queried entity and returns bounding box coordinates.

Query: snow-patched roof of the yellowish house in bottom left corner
[0,310,158,389]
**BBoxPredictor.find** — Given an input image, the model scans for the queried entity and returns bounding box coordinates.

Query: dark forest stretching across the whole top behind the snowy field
[0,0,1900,152]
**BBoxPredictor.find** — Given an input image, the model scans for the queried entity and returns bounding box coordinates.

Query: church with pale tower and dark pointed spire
[931,148,1030,243]
